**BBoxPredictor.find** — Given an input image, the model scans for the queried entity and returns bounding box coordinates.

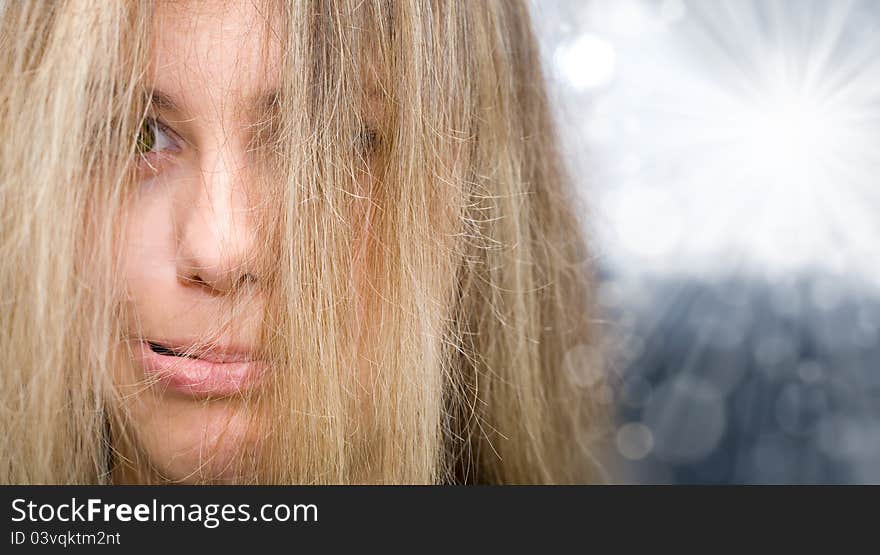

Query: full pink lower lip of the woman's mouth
[136,341,265,397]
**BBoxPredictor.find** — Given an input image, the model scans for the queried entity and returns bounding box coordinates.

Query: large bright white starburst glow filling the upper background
[572,1,880,282]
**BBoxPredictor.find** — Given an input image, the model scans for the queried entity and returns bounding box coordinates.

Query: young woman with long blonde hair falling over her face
[0,0,604,483]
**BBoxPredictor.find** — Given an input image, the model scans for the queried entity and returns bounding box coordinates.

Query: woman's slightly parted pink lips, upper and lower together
[135,340,265,397]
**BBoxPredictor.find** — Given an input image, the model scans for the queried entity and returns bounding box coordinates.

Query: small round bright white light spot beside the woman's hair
[555,33,616,91]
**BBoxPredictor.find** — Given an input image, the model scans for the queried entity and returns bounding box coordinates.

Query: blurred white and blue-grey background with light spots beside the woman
[531,0,880,483]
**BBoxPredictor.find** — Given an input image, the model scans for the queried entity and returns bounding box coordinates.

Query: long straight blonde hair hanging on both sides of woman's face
[0,0,606,483]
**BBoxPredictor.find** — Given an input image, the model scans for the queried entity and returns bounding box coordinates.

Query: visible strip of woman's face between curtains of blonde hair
[117,1,280,481]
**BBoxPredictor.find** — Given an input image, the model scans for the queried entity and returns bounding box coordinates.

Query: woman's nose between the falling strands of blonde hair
[175,145,257,294]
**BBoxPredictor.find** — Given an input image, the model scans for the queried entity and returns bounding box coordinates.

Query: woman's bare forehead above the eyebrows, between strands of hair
[150,0,280,111]
